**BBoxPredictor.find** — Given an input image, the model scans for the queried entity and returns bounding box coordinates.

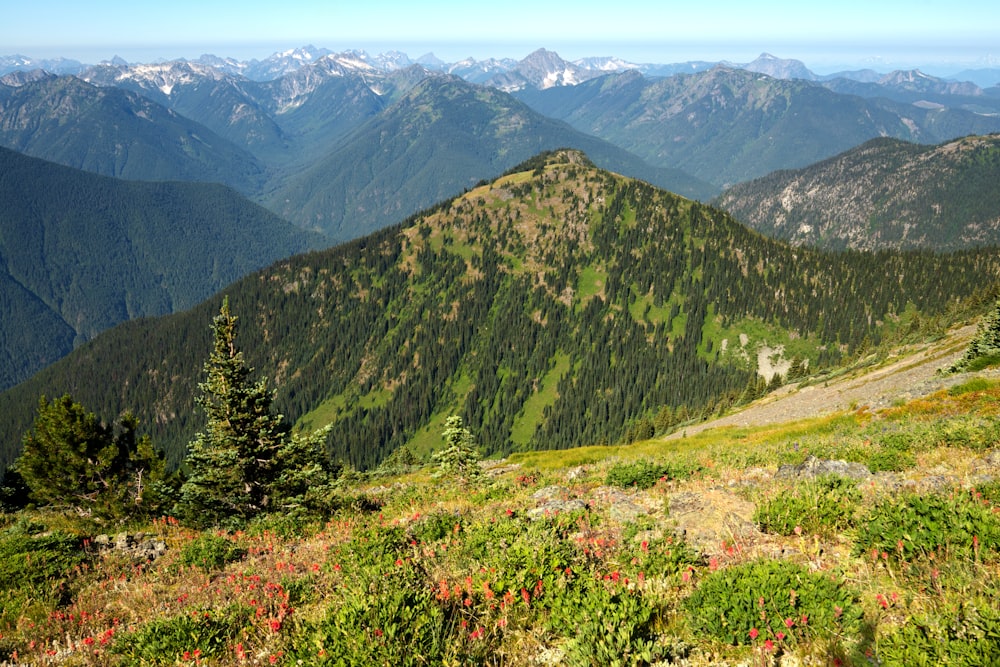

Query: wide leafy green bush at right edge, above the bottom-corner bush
[854,491,1000,562]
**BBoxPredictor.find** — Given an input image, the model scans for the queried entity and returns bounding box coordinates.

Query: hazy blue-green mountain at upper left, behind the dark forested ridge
[0,76,265,193]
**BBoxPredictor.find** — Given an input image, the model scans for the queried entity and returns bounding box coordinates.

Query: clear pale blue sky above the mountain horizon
[0,0,1000,73]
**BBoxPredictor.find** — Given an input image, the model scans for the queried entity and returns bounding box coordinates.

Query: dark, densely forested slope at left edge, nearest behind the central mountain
[0,148,327,388]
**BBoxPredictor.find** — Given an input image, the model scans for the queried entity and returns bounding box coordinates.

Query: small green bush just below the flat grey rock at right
[753,476,861,535]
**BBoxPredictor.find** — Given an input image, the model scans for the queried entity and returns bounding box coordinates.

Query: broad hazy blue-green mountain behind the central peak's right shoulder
[517,67,1000,187]
